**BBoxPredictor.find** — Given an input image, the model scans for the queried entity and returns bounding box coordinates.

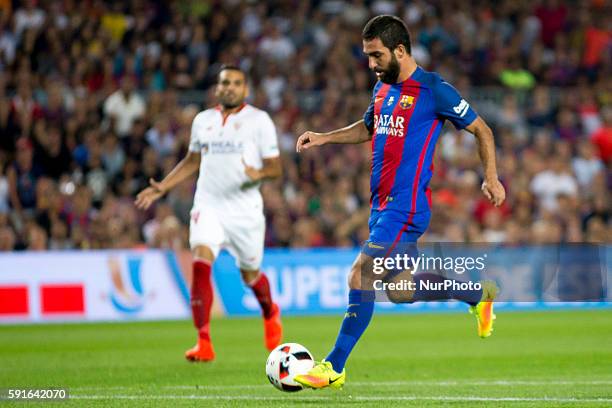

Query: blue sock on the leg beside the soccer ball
[325,289,375,373]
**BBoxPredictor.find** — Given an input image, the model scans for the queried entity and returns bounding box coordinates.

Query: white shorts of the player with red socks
[189,207,266,270]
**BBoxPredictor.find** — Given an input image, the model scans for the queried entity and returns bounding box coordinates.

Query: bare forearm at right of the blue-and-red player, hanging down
[465,116,506,207]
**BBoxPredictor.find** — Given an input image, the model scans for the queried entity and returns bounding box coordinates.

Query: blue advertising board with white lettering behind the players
[214,244,612,316]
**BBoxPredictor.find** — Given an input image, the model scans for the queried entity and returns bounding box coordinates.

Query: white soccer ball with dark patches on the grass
[266,343,314,392]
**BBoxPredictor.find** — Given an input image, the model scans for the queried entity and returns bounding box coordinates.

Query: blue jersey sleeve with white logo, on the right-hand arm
[434,80,478,129]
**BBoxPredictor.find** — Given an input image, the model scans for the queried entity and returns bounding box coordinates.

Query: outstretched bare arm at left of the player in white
[134,152,202,210]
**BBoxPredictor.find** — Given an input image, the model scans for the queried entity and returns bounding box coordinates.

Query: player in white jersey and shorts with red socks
[135,66,282,361]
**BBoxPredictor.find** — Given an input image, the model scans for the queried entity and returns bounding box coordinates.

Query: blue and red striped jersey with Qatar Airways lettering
[363,67,477,214]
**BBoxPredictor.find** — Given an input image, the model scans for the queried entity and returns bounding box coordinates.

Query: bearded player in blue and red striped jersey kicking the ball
[296,15,505,388]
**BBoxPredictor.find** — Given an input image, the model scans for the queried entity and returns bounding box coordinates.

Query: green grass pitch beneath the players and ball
[0,310,612,407]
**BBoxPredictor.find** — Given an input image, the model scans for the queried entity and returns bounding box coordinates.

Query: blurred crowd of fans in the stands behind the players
[0,0,612,250]
